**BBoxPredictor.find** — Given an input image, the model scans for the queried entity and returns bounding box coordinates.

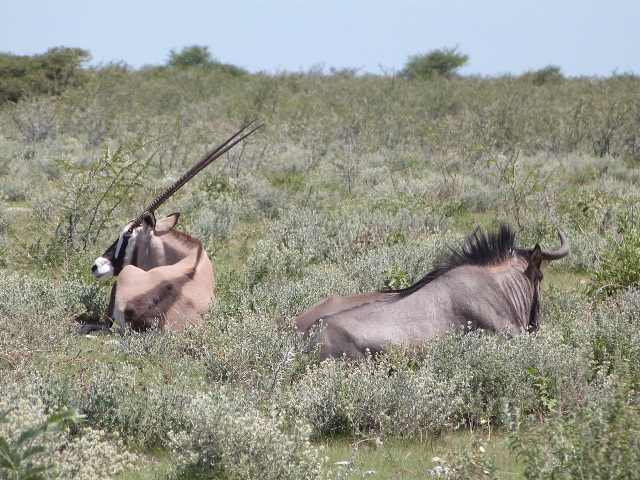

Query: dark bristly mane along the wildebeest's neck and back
[385,224,527,300]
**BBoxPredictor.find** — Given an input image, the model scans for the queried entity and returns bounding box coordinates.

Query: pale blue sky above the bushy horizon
[0,0,640,76]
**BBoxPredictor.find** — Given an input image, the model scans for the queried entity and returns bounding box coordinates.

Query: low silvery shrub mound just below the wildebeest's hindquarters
[283,361,462,436]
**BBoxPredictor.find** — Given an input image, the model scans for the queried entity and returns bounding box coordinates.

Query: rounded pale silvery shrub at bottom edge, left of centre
[171,387,326,480]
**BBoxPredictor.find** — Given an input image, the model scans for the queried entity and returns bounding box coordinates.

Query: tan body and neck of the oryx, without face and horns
[109,214,215,331]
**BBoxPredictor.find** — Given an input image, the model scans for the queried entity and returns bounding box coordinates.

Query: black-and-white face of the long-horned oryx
[91,212,156,282]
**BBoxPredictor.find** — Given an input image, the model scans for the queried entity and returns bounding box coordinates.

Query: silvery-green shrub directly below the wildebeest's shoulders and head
[420,328,590,427]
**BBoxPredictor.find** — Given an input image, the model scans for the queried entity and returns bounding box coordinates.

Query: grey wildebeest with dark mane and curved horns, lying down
[296,225,569,361]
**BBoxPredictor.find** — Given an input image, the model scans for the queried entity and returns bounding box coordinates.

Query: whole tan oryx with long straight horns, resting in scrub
[91,124,262,331]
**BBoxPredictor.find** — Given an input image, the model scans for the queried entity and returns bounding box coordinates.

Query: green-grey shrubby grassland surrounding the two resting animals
[0,65,640,479]
